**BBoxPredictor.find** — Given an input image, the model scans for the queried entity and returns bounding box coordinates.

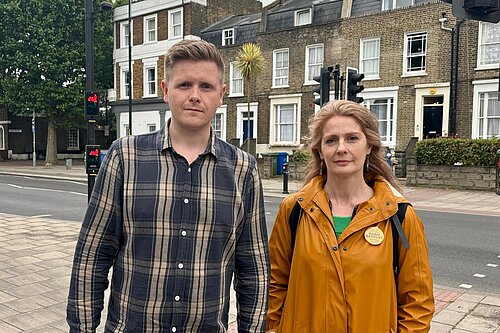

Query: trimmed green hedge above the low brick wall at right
[415,138,500,167]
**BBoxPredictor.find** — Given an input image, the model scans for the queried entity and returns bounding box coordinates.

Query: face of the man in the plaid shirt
[161,60,226,131]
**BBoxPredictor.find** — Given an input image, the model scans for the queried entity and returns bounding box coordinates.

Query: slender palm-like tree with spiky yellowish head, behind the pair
[236,43,264,152]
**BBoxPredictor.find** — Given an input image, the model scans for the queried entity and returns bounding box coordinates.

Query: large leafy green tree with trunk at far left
[0,0,113,165]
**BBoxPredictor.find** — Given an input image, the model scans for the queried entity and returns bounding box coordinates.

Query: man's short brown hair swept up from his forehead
[165,40,224,83]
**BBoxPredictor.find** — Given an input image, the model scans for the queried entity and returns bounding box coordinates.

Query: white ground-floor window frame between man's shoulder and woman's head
[269,94,302,147]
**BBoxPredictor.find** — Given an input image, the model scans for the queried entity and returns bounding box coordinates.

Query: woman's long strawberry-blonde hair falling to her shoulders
[304,100,401,190]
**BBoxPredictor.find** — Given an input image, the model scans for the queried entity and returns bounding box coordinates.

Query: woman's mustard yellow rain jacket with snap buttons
[267,176,434,333]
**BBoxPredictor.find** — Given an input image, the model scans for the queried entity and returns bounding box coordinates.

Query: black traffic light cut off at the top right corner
[447,0,500,23]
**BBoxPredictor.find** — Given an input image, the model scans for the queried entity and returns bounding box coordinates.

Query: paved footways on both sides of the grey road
[0,160,500,333]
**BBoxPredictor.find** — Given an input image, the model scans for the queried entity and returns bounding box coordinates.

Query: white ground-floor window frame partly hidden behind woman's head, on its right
[358,87,399,149]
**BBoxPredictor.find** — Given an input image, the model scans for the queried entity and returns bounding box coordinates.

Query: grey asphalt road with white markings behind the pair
[0,175,500,294]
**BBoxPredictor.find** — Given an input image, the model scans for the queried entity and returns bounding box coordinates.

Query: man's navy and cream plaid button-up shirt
[67,127,269,333]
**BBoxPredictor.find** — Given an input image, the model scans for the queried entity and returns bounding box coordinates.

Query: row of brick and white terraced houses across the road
[113,0,500,163]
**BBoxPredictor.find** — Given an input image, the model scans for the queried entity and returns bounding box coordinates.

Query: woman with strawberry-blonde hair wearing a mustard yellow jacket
[267,101,434,333]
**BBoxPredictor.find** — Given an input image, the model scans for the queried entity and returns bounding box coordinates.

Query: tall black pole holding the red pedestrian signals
[85,0,96,201]
